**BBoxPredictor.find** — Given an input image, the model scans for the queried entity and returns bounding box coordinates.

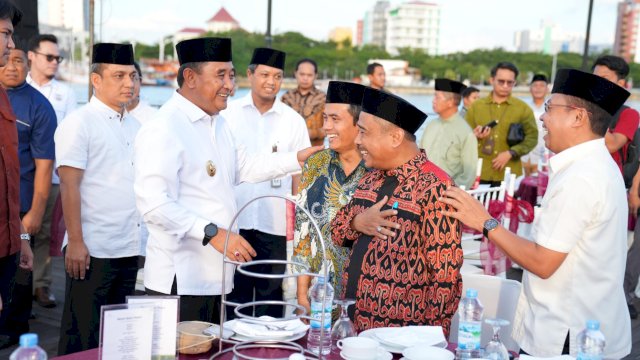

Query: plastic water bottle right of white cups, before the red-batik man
[456,289,484,359]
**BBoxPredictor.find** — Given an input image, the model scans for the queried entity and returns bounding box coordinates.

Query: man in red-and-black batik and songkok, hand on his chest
[331,88,462,335]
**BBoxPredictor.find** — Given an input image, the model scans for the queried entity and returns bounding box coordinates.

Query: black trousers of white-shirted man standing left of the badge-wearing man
[58,251,138,355]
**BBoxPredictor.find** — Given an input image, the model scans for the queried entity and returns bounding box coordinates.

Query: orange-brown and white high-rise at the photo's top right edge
[613,0,640,62]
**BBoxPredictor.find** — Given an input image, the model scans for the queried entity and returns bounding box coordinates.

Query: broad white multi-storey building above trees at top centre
[385,1,440,55]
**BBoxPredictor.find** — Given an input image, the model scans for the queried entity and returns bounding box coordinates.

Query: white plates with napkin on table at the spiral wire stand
[224,316,309,341]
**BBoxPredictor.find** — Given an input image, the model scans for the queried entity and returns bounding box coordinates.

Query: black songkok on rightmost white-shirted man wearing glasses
[551,69,629,115]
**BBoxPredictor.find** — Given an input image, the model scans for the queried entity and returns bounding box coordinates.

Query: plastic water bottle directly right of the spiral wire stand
[307,277,333,355]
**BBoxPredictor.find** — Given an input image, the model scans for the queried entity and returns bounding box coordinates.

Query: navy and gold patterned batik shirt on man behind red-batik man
[293,149,367,294]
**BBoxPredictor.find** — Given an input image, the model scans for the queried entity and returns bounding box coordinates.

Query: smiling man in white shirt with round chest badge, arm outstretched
[134,38,321,322]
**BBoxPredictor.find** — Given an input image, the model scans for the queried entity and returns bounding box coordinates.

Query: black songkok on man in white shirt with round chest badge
[176,37,231,65]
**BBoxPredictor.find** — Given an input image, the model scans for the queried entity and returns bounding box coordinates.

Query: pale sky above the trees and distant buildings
[39,0,619,53]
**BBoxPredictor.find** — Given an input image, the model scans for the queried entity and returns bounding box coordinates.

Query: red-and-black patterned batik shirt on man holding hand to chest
[332,151,462,336]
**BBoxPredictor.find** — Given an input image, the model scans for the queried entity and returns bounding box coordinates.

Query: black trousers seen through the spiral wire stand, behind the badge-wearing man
[227,230,287,320]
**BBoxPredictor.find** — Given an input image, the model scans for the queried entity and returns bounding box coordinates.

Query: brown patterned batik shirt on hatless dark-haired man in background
[282,87,327,146]
